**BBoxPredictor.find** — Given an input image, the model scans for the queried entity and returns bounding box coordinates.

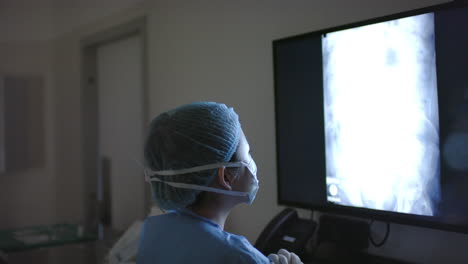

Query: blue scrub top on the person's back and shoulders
[137,210,270,264]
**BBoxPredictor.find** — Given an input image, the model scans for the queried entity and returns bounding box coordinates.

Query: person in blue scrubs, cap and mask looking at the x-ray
[137,102,301,264]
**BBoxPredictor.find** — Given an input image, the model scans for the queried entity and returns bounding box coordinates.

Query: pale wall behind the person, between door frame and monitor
[48,0,468,263]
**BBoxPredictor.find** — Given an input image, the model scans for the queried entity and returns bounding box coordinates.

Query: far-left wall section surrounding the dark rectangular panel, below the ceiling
[0,41,55,229]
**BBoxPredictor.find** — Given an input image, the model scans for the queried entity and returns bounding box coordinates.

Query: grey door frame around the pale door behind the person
[80,17,151,234]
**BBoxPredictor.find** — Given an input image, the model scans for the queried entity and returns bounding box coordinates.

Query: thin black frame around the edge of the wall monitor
[272,0,468,234]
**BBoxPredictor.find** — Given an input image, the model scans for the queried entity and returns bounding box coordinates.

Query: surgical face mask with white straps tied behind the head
[144,157,259,204]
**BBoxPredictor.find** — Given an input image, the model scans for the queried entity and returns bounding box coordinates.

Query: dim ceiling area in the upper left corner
[0,0,145,42]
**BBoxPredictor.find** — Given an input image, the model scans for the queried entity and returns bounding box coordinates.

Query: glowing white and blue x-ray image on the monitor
[322,14,440,216]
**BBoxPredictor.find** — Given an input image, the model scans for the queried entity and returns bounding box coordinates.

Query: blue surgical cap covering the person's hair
[144,102,241,210]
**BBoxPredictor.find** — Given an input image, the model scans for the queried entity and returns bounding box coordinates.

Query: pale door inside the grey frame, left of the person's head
[97,36,145,230]
